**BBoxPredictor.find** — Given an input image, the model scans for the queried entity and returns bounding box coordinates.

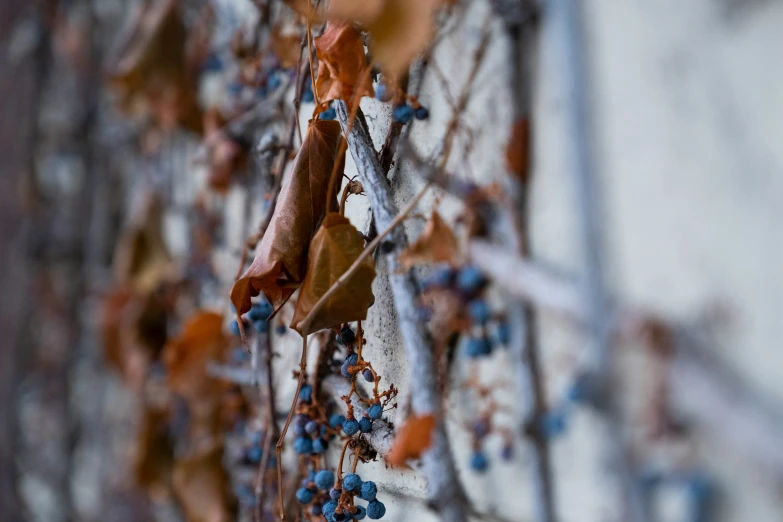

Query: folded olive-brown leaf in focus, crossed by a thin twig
[291,213,375,334]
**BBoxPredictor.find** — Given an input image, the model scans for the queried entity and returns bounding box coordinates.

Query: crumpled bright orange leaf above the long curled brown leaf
[314,22,373,112]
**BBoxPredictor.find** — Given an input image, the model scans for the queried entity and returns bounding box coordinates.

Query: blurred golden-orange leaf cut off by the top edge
[329,0,442,78]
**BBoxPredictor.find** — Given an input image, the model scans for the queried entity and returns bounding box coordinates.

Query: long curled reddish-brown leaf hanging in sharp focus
[231,120,345,315]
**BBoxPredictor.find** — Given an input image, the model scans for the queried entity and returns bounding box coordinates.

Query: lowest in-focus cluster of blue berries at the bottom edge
[296,469,386,522]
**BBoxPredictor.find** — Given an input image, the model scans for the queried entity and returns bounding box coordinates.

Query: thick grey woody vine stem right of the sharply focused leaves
[335,101,467,522]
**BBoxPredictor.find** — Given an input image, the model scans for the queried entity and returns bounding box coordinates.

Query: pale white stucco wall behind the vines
[181,0,783,522]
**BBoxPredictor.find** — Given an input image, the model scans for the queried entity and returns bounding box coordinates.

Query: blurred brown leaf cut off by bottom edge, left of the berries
[172,446,236,522]
